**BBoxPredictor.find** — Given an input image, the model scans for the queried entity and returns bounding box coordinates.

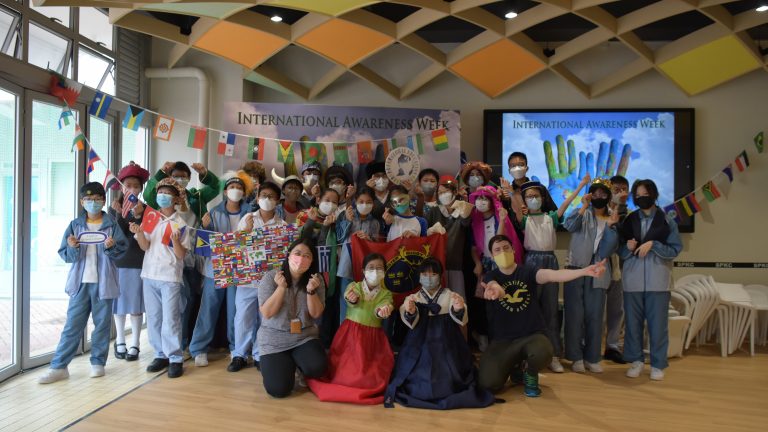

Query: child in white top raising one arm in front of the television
[518,175,589,373]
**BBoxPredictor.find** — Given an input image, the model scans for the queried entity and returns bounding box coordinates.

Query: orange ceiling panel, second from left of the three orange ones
[296,19,392,67]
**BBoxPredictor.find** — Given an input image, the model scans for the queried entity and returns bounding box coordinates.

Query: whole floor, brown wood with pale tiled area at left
[0,347,768,432]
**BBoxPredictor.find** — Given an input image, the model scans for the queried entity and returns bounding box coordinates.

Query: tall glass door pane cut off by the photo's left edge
[0,88,19,370]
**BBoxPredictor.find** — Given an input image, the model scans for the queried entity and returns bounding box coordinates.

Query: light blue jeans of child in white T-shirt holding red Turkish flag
[144,279,186,363]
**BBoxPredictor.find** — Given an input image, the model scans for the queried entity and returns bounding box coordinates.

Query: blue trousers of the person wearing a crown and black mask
[563,277,605,363]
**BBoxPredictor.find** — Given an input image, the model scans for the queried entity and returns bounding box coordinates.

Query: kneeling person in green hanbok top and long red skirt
[307,254,395,405]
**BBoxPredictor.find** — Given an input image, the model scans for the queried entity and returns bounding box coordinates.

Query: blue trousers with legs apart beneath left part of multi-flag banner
[189,277,237,357]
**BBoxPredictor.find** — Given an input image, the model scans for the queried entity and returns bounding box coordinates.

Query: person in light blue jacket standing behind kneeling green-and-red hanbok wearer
[336,188,381,322]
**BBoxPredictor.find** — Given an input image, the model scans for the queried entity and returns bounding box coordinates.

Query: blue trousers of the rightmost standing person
[624,291,670,369]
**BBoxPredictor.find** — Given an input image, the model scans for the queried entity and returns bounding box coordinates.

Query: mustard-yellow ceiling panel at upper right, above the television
[659,35,760,95]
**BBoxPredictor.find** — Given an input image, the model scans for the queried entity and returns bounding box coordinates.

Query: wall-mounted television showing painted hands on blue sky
[483,108,694,232]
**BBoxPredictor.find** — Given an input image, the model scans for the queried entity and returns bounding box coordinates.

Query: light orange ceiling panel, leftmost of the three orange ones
[194,21,288,69]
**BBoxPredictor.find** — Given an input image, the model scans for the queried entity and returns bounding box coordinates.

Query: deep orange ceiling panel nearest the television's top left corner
[450,39,545,97]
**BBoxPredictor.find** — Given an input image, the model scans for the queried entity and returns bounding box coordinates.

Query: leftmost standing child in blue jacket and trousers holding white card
[38,182,128,384]
